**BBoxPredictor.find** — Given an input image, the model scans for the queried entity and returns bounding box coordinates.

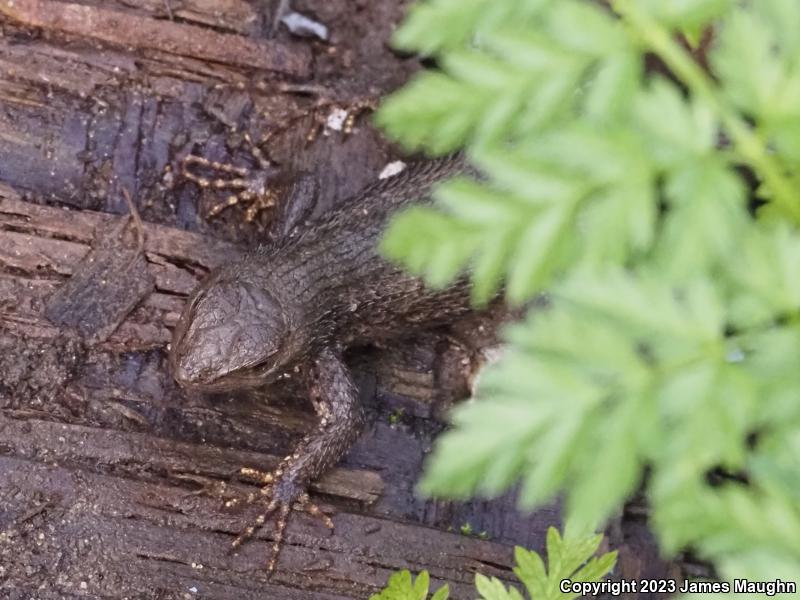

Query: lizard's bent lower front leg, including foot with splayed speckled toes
[233,349,365,573]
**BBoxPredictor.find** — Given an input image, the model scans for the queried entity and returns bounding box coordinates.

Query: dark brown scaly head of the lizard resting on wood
[169,265,291,390]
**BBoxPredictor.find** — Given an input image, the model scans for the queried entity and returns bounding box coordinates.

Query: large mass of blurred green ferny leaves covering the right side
[377,0,800,580]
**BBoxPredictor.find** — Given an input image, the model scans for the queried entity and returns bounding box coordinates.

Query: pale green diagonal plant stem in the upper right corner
[612,0,800,225]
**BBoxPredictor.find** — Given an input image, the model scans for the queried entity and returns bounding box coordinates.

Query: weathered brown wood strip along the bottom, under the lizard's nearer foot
[0,454,510,598]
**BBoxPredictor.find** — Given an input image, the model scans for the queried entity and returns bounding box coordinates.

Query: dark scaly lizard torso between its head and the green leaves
[252,155,469,345]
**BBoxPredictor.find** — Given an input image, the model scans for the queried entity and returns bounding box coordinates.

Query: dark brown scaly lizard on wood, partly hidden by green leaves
[170,157,470,572]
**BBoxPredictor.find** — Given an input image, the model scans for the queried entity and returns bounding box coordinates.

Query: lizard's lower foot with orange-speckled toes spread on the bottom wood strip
[226,467,333,574]
